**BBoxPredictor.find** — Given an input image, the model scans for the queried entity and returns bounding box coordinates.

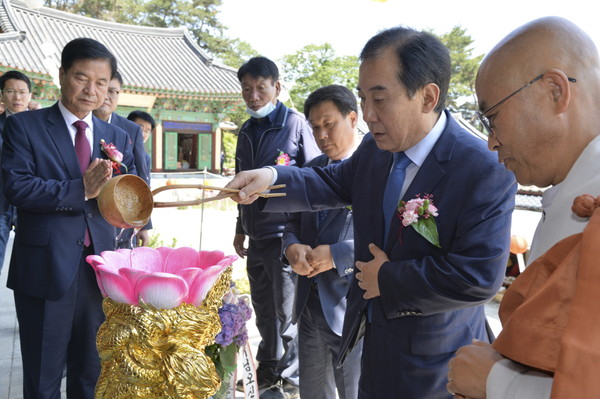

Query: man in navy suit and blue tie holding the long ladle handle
[229,27,516,399]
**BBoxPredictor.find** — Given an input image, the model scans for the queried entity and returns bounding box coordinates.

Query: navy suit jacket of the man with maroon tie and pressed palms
[2,104,135,300]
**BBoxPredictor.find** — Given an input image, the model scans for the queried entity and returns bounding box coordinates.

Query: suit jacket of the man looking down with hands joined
[282,155,354,335]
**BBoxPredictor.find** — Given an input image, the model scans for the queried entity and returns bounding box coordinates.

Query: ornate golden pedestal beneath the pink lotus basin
[95,267,231,399]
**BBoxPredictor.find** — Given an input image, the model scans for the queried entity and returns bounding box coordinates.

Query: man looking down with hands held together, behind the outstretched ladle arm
[282,85,361,399]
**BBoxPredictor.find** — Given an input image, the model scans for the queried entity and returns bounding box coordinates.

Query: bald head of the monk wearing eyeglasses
[475,17,600,187]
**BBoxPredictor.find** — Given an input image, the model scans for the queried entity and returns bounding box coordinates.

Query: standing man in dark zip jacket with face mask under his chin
[233,57,320,399]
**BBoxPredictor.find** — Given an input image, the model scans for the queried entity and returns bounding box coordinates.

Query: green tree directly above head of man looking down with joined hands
[282,43,358,111]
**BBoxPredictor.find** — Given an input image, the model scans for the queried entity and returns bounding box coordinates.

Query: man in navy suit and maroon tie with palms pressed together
[2,38,135,399]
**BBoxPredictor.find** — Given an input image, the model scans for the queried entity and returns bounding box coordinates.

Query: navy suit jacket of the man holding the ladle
[265,112,516,399]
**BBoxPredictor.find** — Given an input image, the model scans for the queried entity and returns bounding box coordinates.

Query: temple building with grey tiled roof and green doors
[0,0,243,172]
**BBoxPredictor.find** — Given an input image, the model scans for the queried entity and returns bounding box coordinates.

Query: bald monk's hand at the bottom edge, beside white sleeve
[446,340,502,399]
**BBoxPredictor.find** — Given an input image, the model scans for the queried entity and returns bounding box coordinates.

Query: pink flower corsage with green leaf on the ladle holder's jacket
[398,194,441,248]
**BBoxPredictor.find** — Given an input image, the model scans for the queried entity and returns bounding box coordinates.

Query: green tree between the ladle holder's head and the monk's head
[436,26,483,122]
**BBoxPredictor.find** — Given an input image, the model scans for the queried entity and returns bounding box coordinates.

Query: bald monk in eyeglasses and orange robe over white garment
[448,17,600,399]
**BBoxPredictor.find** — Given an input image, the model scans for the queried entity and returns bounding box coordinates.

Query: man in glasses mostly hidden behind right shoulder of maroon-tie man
[94,71,152,248]
